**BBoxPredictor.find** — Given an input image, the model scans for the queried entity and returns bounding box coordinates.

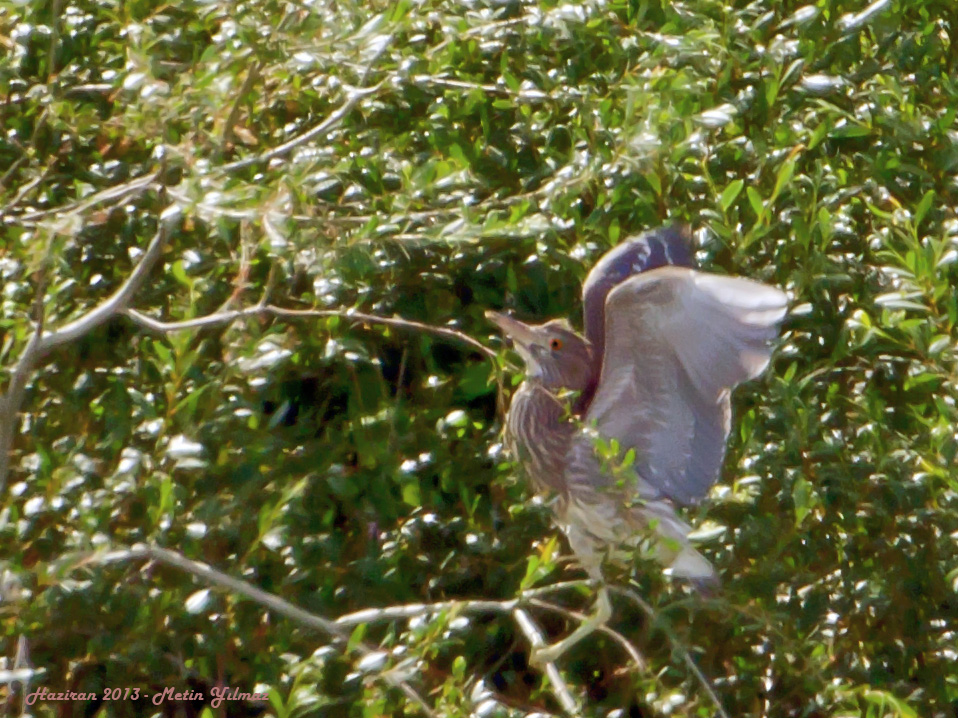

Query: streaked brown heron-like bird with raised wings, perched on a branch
[486,226,788,666]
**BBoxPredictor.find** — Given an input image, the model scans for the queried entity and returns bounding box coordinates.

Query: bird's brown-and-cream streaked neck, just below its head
[506,381,575,494]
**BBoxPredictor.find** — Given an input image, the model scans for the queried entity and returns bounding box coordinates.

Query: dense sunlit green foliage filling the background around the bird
[0,0,958,717]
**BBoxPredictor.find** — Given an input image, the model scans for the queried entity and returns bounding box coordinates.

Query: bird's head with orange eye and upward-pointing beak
[486,312,593,391]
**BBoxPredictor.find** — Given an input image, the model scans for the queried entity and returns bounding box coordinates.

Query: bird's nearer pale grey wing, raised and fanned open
[570,267,787,504]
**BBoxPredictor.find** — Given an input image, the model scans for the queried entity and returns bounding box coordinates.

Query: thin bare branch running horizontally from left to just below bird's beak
[125,304,498,359]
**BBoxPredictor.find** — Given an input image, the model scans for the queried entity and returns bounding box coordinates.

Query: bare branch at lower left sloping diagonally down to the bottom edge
[81,544,438,718]
